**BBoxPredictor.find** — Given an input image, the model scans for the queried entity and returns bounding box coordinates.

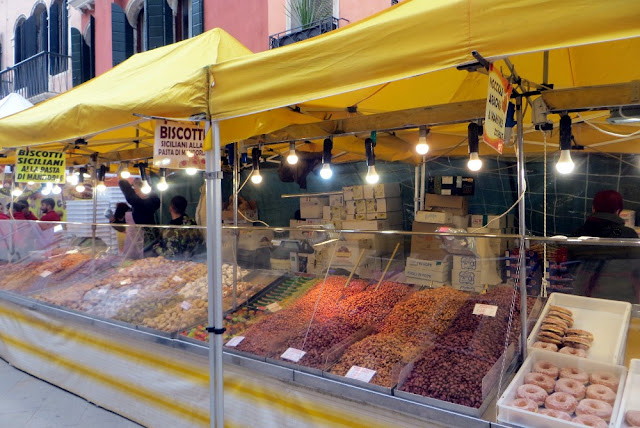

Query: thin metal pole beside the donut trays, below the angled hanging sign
[516,97,527,360]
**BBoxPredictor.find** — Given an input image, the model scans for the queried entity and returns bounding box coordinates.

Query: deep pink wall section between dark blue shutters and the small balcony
[204,0,269,52]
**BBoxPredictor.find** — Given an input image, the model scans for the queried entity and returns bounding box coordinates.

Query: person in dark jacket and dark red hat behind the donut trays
[569,190,640,303]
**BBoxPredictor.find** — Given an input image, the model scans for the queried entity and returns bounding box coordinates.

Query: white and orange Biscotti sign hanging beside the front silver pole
[153,120,206,169]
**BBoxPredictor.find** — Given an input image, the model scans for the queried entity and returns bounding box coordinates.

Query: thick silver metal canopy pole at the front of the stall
[205,121,224,428]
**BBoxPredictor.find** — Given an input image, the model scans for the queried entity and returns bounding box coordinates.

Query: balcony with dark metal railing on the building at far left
[0,52,72,104]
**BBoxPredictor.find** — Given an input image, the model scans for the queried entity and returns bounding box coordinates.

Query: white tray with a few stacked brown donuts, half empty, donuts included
[527,293,631,364]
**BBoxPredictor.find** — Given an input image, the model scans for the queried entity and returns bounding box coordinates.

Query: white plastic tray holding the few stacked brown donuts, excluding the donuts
[527,293,631,364]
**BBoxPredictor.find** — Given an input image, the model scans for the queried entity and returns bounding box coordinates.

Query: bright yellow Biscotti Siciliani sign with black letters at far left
[15,149,66,183]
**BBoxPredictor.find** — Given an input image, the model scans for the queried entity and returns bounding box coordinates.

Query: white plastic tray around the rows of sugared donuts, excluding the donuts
[497,349,628,428]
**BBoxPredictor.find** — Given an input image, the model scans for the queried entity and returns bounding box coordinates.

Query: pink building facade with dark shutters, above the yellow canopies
[0,0,397,103]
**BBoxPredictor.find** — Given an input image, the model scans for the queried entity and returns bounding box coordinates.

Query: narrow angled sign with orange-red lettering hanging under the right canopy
[482,64,513,154]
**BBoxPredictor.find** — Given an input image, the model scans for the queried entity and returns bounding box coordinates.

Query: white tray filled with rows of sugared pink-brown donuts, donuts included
[497,349,627,428]
